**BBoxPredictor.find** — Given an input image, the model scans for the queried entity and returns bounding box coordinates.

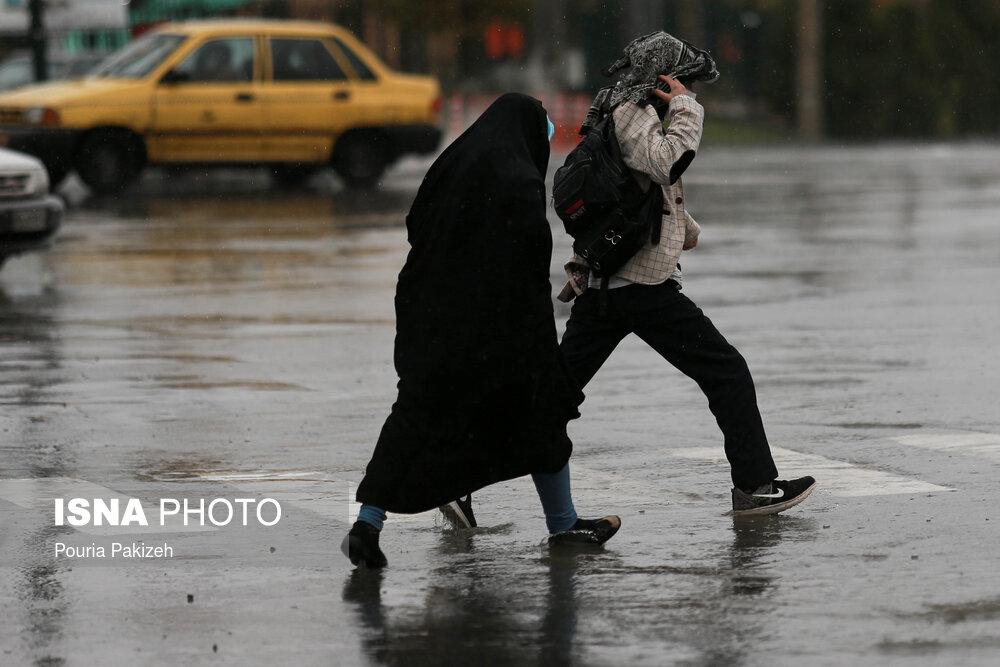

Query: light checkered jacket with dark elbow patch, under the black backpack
[559,95,705,301]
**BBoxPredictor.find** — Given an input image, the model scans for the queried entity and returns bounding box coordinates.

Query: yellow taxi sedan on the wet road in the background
[0,19,441,193]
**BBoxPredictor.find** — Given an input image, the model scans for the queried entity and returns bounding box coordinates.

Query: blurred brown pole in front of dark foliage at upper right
[795,0,823,141]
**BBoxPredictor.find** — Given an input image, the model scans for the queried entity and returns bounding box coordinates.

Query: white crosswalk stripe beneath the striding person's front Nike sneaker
[668,447,954,498]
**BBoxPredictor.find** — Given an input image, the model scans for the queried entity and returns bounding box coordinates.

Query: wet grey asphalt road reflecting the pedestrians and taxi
[0,145,1000,666]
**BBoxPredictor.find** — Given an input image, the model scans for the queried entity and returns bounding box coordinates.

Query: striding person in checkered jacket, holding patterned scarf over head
[555,32,816,515]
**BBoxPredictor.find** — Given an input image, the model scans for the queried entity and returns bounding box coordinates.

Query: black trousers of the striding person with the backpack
[560,281,778,489]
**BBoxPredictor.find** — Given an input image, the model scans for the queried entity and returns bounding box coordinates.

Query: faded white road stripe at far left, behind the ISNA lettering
[0,477,217,535]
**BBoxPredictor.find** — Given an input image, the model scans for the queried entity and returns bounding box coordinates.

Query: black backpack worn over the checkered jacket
[552,114,663,290]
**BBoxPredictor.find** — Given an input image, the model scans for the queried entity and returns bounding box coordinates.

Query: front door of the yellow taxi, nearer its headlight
[147,36,264,162]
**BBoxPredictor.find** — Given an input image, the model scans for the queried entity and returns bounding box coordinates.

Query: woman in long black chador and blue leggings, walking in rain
[342,94,620,567]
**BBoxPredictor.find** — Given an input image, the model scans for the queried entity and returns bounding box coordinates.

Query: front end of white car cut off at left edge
[0,148,65,266]
